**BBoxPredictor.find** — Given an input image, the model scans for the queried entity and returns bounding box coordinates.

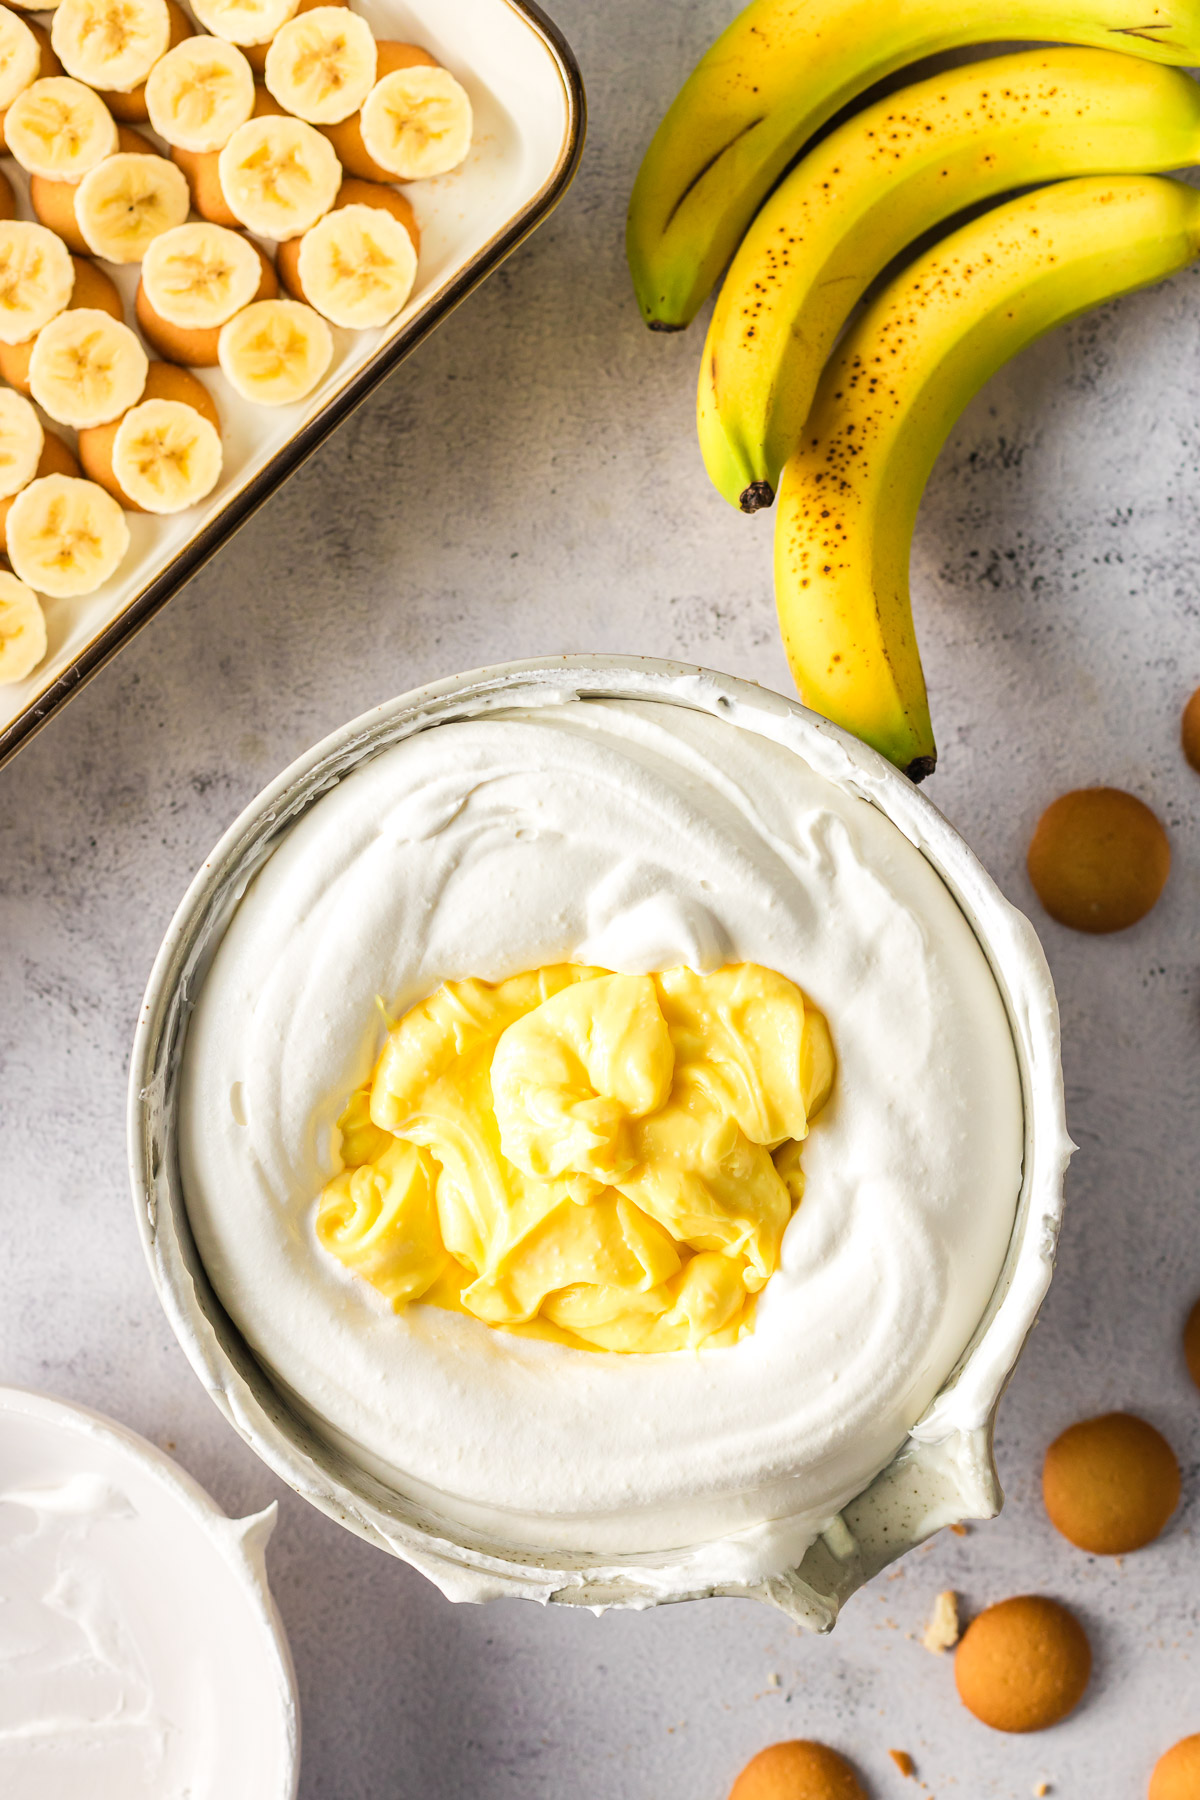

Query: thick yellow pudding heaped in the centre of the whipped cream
[317,963,833,1352]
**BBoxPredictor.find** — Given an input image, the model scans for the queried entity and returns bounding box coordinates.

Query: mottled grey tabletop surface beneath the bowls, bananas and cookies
[0,0,1200,1800]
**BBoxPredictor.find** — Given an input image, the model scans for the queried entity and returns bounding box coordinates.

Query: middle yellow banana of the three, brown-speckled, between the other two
[696,49,1200,513]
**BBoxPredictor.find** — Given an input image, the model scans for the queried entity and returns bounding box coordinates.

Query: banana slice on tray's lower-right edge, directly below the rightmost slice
[297,205,417,331]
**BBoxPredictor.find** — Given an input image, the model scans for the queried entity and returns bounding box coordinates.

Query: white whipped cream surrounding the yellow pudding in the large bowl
[180,700,1022,1568]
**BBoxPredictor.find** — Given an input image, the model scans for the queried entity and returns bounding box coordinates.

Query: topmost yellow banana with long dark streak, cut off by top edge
[626,0,1200,331]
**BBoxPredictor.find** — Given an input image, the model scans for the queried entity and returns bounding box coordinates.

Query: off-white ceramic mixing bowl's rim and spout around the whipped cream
[130,657,1070,1631]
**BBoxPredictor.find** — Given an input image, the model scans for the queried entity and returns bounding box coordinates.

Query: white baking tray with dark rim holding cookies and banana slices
[0,0,585,763]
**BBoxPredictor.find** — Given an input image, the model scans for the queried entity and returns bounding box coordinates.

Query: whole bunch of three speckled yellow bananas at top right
[628,0,1200,779]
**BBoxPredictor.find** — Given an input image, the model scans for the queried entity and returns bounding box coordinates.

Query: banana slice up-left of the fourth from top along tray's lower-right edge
[29,306,149,430]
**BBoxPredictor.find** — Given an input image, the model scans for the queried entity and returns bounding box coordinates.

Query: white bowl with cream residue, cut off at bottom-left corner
[0,1390,297,1800]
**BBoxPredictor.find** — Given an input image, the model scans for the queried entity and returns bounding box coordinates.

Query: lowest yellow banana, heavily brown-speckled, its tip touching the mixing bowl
[775,175,1200,781]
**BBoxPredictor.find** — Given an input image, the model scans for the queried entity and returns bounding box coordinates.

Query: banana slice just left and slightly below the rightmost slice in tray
[218,117,342,239]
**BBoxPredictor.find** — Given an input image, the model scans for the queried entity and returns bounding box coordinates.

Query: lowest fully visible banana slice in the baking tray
[7,475,130,599]
